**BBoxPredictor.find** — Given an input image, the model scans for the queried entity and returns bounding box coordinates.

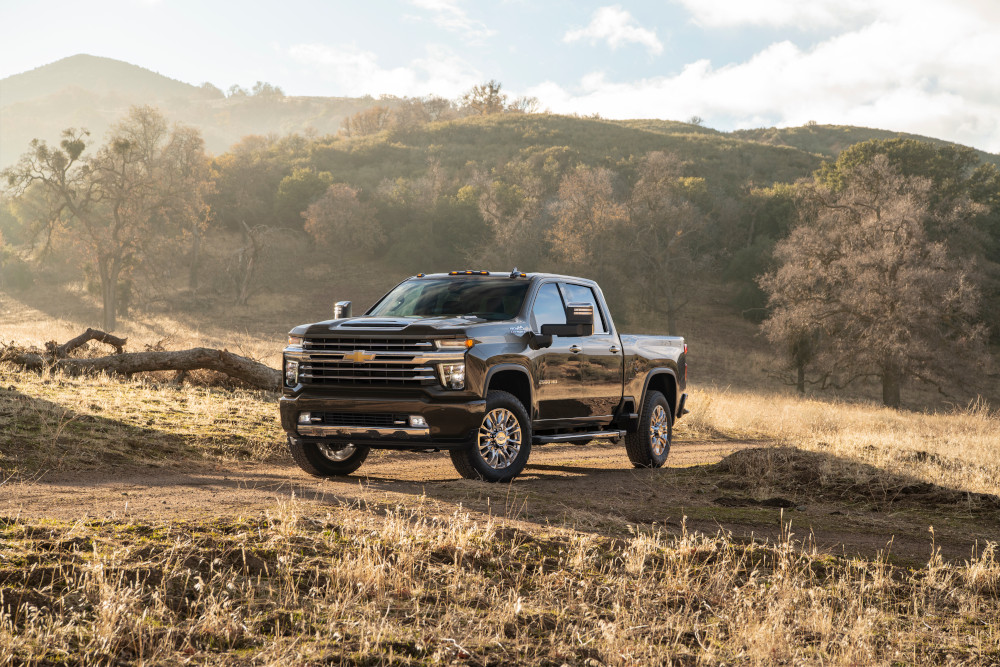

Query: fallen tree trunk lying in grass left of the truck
[0,329,281,391]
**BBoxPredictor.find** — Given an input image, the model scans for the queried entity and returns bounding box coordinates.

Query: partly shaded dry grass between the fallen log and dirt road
[0,365,284,477]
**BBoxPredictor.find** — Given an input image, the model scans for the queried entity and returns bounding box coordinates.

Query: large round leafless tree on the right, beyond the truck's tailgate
[760,155,984,407]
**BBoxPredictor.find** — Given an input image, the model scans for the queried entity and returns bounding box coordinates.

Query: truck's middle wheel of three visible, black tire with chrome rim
[450,391,531,482]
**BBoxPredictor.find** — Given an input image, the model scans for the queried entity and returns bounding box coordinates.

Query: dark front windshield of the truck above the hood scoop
[368,278,528,320]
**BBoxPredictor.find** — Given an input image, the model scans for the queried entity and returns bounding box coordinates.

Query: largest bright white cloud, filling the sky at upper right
[527,0,1000,152]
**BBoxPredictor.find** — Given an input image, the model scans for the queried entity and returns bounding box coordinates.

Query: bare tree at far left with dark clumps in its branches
[3,107,206,331]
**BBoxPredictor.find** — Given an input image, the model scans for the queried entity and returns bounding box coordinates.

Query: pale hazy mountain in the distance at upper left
[0,54,379,169]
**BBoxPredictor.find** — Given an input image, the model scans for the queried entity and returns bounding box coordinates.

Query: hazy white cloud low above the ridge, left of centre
[288,44,483,97]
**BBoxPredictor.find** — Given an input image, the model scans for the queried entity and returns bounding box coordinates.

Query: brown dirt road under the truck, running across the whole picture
[0,441,995,564]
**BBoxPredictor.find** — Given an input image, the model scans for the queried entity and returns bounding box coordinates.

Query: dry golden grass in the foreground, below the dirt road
[0,502,1000,665]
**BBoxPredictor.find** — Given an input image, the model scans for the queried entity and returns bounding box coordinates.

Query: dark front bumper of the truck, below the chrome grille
[279,394,486,450]
